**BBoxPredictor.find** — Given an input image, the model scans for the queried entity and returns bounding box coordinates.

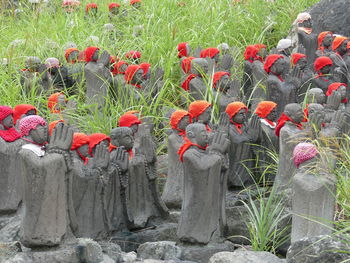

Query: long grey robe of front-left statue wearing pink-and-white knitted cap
[19,144,70,247]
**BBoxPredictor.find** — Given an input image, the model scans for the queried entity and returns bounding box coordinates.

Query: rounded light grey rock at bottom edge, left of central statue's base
[137,241,182,260]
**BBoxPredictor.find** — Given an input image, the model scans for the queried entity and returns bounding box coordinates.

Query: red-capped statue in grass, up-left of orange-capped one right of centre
[213,71,239,112]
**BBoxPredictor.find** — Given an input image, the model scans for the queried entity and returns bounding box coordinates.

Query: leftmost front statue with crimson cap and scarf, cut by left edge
[0,106,23,214]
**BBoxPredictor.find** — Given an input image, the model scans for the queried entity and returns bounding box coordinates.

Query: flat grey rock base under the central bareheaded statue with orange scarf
[180,242,234,263]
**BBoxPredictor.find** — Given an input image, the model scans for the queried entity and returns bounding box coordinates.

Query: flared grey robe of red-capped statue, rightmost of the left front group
[127,154,168,229]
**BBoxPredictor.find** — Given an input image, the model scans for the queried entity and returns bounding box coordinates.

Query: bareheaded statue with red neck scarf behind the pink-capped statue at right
[274,103,306,192]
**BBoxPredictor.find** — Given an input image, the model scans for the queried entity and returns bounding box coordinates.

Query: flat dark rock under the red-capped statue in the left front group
[112,223,178,252]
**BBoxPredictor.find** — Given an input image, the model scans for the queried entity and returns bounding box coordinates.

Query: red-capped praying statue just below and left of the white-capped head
[264,55,300,116]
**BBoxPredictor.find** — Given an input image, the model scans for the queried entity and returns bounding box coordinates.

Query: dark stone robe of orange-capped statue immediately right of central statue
[228,125,254,187]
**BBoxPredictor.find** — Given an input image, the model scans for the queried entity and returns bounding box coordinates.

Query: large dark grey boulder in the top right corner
[309,0,350,36]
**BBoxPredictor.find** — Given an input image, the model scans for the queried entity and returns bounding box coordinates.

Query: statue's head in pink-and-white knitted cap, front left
[19,115,47,145]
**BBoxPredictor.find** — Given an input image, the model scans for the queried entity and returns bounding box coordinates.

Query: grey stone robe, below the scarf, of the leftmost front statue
[0,138,24,213]
